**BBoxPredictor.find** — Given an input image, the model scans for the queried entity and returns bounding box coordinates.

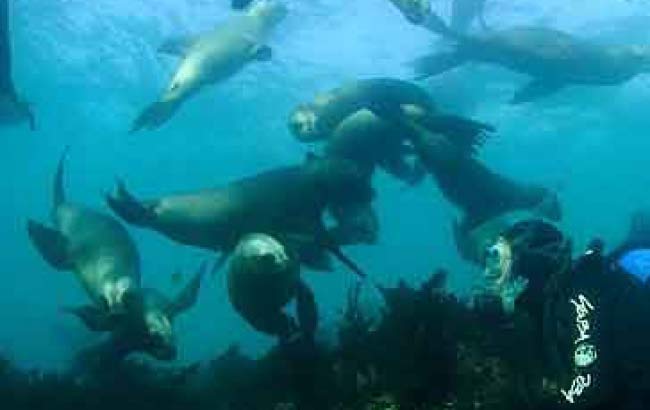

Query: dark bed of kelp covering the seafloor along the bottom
[0,271,547,410]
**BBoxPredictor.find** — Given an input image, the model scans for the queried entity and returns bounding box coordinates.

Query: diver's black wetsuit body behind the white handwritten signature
[541,243,650,410]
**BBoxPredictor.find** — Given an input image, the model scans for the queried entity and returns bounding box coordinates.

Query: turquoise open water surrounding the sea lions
[0,0,650,367]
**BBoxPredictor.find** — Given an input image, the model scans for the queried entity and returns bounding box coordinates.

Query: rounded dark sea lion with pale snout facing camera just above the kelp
[226,234,318,340]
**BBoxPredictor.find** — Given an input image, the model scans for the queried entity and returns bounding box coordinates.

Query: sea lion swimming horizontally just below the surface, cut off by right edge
[413,23,650,104]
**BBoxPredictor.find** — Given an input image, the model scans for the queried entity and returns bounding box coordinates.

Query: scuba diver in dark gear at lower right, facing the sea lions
[476,213,650,410]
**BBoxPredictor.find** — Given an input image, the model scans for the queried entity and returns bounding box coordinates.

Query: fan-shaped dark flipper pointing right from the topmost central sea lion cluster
[423,115,495,154]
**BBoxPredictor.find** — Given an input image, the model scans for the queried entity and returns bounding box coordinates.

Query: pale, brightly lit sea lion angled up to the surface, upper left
[131,0,287,132]
